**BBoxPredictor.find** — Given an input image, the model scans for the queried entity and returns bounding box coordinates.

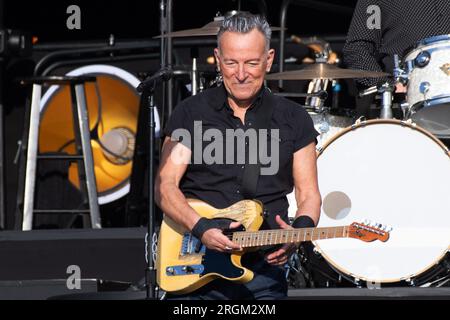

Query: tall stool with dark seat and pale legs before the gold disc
[18,77,101,230]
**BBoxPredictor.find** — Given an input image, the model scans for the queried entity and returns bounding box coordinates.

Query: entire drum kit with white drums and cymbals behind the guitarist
[159,16,450,287]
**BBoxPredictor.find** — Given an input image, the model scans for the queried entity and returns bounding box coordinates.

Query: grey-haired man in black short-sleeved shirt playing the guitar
[156,13,321,299]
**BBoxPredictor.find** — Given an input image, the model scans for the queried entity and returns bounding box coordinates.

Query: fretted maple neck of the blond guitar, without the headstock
[232,226,349,248]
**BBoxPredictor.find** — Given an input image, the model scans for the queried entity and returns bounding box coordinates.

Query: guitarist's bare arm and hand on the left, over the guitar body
[155,137,239,251]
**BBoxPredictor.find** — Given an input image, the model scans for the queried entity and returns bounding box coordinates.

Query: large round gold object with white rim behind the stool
[39,65,159,204]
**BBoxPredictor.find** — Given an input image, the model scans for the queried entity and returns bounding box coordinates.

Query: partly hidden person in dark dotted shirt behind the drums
[343,0,450,116]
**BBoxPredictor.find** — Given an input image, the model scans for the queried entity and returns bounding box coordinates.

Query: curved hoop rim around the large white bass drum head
[313,119,450,283]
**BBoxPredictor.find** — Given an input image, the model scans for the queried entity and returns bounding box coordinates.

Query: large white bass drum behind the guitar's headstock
[288,120,450,285]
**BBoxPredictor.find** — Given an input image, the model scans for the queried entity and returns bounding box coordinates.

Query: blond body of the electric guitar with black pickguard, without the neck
[156,199,263,294]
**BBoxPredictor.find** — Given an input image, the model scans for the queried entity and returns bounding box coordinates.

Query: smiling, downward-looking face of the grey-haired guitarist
[214,29,274,103]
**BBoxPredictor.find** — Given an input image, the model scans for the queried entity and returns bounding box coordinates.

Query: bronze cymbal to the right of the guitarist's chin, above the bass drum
[266,63,391,80]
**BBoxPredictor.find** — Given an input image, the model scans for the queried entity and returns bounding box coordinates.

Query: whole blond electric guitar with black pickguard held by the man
[156,199,389,294]
